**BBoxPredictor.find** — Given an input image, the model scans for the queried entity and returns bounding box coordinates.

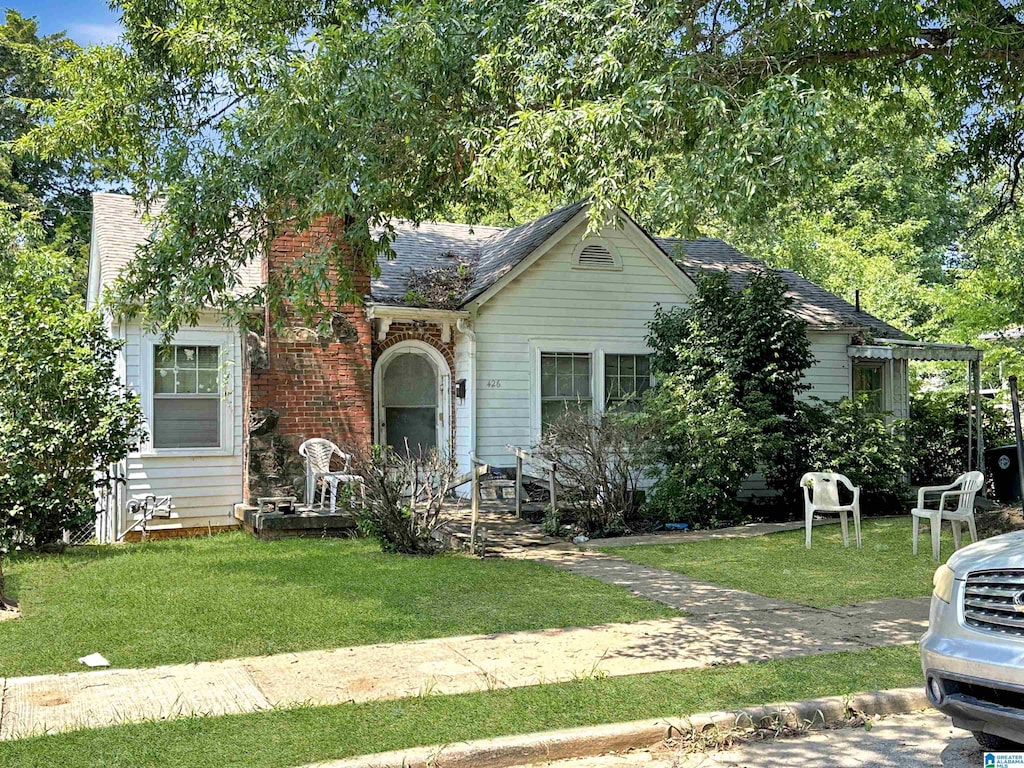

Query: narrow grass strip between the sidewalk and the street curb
[0,646,921,768]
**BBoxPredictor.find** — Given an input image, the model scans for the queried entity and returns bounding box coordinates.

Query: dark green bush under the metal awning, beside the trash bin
[907,389,1014,485]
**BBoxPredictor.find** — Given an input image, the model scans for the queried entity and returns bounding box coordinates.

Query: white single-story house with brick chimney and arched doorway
[88,193,977,541]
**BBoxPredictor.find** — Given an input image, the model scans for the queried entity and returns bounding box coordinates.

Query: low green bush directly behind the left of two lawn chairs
[765,395,908,518]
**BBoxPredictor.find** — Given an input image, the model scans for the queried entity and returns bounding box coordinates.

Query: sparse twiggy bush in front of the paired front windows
[534,411,650,537]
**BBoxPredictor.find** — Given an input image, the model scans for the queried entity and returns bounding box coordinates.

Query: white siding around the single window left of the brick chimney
[121,315,243,529]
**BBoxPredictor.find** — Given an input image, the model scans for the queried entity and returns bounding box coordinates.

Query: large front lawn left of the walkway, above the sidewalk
[0,534,679,675]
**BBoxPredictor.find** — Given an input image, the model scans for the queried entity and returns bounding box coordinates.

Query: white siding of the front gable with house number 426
[468,218,686,466]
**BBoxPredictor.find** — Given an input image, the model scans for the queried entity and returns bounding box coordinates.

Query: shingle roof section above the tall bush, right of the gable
[654,238,908,339]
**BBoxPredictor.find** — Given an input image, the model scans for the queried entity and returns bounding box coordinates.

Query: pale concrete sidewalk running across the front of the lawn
[0,585,928,739]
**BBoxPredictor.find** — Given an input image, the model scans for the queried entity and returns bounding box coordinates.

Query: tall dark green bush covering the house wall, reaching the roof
[644,270,814,527]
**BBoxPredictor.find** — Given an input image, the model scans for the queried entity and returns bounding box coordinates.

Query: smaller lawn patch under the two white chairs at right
[603,515,950,607]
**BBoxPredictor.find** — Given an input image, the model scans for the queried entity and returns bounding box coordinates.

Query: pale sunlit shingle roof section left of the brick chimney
[92,193,263,303]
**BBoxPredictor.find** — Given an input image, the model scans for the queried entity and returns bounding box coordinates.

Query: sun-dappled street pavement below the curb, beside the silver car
[520,711,982,768]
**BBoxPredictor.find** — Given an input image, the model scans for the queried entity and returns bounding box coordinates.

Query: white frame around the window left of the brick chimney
[139,331,237,456]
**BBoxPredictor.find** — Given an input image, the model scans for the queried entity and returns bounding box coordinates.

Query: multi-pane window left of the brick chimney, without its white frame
[153,344,220,449]
